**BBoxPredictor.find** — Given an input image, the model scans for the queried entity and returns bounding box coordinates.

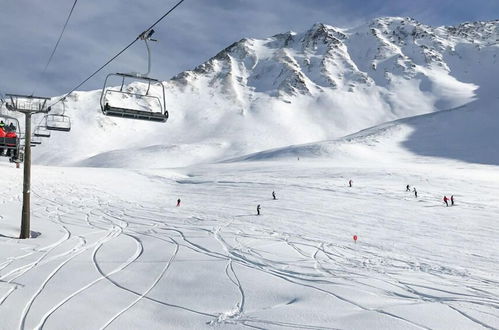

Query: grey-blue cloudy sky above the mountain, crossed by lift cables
[0,0,499,96]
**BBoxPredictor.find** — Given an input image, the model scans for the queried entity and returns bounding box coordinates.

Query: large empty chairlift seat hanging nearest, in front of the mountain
[100,73,168,122]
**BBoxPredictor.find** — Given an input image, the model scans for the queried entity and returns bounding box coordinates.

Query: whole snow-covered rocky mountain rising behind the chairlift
[15,17,499,167]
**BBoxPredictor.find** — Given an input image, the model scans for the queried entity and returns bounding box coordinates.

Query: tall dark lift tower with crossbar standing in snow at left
[5,94,50,239]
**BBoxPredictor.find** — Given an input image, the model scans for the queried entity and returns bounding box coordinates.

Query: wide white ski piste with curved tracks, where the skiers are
[0,143,499,329]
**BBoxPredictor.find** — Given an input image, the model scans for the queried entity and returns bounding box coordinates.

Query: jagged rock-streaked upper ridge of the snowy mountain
[173,17,498,98]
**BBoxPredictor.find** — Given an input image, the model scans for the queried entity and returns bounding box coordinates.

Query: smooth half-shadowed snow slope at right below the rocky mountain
[232,97,499,165]
